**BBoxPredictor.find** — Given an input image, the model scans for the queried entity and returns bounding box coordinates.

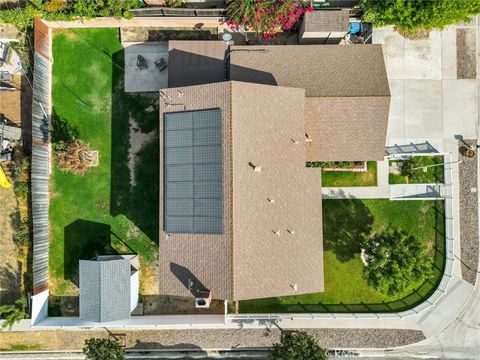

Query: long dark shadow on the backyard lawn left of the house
[110,50,160,243]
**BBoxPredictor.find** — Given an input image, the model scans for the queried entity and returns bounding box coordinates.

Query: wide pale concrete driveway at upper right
[373,20,478,152]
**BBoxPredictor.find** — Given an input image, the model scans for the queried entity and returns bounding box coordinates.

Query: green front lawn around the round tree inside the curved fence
[240,200,445,313]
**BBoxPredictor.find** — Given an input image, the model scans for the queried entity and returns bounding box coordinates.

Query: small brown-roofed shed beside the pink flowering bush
[299,9,350,45]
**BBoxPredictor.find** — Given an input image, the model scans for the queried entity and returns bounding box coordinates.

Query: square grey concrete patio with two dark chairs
[124,42,168,92]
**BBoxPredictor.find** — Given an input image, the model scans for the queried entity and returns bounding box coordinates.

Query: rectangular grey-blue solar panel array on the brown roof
[163,109,223,234]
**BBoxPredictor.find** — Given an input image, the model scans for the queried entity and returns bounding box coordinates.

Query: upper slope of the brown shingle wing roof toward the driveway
[230,45,390,97]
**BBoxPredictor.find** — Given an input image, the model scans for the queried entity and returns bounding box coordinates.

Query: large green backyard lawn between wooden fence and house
[49,28,159,296]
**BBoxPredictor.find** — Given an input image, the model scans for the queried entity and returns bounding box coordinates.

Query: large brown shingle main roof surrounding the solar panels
[159,82,323,300]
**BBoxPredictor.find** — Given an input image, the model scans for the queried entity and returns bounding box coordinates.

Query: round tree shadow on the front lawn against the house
[323,199,373,262]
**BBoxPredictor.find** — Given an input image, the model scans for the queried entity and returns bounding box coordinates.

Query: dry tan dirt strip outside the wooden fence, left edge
[0,188,21,305]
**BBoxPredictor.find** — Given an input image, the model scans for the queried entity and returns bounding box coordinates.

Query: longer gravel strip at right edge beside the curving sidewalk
[458,140,478,285]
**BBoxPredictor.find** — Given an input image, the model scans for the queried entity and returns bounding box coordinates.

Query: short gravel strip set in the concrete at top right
[457,28,476,79]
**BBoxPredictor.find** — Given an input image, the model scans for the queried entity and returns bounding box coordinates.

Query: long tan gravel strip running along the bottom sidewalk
[0,328,425,350]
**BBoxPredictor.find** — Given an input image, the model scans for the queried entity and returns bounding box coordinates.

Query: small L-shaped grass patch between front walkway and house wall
[322,161,377,187]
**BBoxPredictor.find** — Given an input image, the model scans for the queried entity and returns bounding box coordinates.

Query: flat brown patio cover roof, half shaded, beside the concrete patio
[168,40,227,88]
